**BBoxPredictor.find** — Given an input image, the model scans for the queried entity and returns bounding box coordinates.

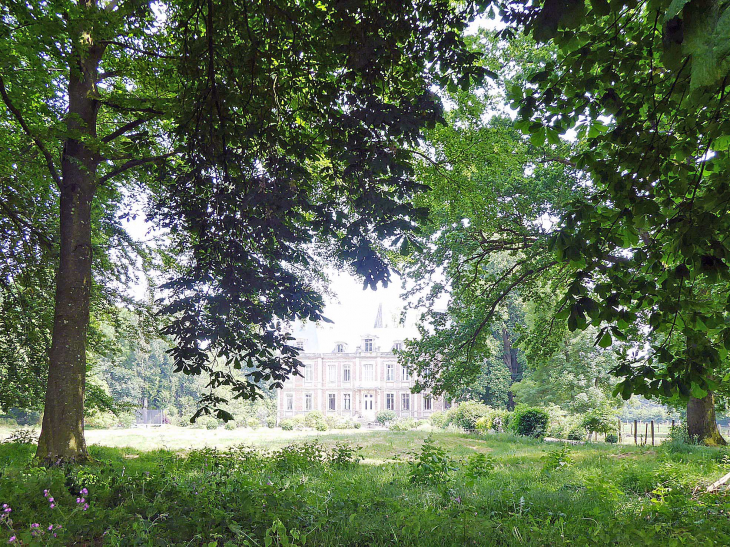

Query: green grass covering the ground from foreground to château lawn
[0,430,730,546]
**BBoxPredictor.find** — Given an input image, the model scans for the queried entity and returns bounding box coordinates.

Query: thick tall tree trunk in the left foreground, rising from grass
[36,23,104,465]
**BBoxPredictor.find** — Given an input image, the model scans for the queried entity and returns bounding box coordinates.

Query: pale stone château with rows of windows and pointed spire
[277,309,449,422]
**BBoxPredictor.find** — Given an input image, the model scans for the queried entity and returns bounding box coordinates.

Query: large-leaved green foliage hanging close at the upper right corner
[500,0,730,399]
